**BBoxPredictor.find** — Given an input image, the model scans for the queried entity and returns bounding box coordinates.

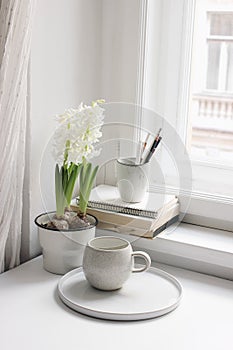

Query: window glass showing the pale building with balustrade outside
[188,0,233,166]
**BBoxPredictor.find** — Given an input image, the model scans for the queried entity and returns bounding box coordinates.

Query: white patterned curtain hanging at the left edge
[0,0,36,272]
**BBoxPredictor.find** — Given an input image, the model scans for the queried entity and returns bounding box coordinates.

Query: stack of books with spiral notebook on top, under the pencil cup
[73,185,179,238]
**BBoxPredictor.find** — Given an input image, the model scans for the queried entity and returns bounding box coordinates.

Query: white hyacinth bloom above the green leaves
[53,100,104,167]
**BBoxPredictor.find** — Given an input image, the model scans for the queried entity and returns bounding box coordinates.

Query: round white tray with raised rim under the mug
[58,267,182,321]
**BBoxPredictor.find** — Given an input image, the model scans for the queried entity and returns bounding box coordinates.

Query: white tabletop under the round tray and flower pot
[0,257,233,350]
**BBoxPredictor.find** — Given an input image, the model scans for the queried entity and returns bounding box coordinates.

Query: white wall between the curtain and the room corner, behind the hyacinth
[24,0,101,258]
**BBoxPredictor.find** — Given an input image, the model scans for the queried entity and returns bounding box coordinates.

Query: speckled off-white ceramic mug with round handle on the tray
[83,236,151,290]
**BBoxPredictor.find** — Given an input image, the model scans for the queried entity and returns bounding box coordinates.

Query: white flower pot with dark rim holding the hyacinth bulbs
[35,213,97,275]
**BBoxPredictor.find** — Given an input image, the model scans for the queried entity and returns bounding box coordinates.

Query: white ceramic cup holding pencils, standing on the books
[117,158,150,203]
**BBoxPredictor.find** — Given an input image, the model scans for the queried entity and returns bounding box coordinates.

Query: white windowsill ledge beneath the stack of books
[97,223,233,280]
